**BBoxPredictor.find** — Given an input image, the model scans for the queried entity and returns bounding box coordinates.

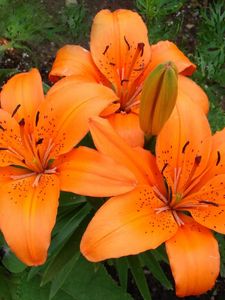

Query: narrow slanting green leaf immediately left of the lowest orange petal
[140,251,173,290]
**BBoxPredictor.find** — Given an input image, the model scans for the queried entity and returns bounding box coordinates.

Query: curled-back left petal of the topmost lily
[49,45,105,82]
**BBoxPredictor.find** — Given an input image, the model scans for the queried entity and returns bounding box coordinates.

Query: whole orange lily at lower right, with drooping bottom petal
[81,94,225,297]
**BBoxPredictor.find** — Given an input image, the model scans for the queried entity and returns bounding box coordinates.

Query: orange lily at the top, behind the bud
[50,9,209,146]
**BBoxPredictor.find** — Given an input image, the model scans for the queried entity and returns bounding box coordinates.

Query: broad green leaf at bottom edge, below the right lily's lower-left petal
[60,257,132,300]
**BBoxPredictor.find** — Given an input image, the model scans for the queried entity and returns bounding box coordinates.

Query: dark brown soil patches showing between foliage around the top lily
[0,0,203,84]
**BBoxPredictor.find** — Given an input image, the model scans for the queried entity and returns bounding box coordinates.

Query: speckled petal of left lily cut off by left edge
[0,109,26,167]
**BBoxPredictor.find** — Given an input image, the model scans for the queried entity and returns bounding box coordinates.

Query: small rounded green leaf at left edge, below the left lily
[2,248,27,273]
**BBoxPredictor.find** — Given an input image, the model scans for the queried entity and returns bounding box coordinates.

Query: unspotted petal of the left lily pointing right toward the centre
[55,147,136,197]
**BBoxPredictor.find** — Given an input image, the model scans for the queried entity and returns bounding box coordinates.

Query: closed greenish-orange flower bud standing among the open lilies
[140,62,177,136]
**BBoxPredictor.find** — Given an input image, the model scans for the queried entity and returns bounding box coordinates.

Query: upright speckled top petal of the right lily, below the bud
[156,91,211,193]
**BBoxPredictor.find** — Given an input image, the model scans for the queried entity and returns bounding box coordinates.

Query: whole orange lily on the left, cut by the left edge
[0,69,138,265]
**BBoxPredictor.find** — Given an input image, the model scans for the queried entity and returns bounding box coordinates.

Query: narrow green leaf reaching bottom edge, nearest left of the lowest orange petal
[127,256,152,300]
